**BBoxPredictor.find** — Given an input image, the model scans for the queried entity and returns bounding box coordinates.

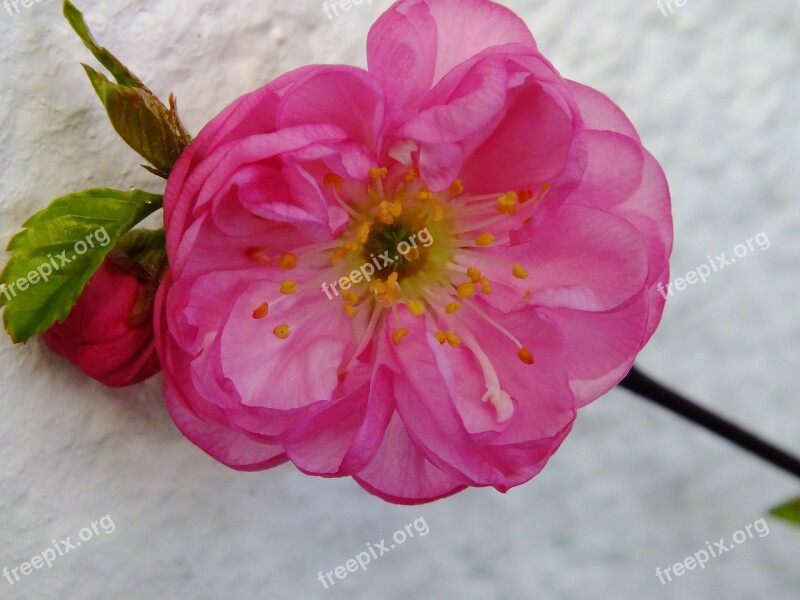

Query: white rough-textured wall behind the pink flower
[0,0,800,600]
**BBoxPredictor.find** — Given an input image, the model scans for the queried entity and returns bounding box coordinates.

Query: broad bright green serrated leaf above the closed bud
[0,189,162,343]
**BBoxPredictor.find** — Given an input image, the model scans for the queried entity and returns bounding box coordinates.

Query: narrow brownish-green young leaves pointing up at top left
[64,0,191,178]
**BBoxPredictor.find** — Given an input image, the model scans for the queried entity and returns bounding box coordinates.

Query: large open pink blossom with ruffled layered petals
[156,0,672,503]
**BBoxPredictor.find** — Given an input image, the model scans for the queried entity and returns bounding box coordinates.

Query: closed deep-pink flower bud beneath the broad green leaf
[44,259,160,387]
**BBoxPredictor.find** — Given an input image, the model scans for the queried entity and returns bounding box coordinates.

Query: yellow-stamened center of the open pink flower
[247,156,550,423]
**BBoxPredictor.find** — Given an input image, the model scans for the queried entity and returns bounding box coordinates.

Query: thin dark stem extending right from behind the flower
[620,367,800,477]
